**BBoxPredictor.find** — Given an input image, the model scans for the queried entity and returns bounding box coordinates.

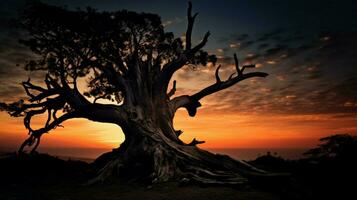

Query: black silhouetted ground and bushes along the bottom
[0,135,357,200]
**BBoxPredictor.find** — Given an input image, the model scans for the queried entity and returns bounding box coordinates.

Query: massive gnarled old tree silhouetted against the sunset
[1,2,267,184]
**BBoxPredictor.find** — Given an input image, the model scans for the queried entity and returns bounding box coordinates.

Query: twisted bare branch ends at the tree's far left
[0,74,80,152]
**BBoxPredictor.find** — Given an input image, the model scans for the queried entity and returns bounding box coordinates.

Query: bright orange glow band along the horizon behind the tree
[0,109,357,152]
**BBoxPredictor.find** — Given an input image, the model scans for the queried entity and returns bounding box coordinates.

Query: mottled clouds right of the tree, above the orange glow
[176,27,357,115]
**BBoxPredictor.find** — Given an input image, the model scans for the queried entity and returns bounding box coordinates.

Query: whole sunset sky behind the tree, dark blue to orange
[0,0,357,156]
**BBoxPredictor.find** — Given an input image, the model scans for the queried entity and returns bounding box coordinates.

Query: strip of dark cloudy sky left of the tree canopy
[0,1,37,101]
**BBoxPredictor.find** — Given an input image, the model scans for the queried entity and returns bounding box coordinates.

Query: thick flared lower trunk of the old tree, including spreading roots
[89,110,265,184]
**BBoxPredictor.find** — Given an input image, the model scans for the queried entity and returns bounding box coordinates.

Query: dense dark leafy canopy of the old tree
[21,3,216,103]
